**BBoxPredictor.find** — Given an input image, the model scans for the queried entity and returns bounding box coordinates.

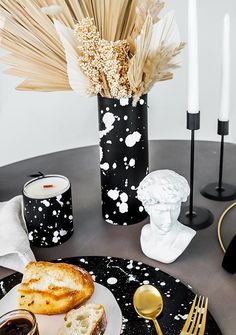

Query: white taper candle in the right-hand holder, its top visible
[219,14,230,121]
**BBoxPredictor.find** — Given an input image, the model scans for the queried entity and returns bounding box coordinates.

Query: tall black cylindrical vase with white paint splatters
[98,95,148,225]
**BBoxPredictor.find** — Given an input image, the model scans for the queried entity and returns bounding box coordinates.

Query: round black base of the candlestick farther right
[200,183,236,201]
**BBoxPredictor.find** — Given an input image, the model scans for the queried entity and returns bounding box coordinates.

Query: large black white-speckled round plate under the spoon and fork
[0,256,222,335]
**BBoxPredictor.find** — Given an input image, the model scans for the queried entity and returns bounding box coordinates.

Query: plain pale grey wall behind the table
[0,0,236,165]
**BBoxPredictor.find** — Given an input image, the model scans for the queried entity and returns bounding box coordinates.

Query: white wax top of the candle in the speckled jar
[23,175,70,199]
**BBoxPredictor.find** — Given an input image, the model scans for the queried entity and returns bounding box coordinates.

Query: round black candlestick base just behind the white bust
[178,206,214,230]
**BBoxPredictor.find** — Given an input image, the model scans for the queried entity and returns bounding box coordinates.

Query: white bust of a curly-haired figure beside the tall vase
[137,170,196,263]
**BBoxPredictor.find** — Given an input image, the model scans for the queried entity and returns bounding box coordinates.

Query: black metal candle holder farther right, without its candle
[200,120,236,201]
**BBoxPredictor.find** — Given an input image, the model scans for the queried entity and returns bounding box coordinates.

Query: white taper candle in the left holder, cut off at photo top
[188,0,199,114]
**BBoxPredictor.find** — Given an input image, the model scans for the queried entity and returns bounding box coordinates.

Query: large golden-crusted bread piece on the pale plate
[18,262,94,315]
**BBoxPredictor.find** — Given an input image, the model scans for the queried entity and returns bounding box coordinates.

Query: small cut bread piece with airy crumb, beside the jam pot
[58,304,107,335]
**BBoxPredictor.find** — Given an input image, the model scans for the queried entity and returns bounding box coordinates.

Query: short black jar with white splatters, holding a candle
[23,175,73,247]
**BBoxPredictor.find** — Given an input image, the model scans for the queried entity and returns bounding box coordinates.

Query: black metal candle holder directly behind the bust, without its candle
[179,112,214,230]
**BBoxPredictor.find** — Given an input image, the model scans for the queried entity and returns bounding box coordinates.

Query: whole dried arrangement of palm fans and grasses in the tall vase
[0,0,184,102]
